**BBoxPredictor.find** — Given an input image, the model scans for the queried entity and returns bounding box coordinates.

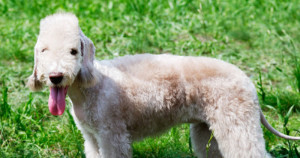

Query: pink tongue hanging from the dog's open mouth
[48,87,68,115]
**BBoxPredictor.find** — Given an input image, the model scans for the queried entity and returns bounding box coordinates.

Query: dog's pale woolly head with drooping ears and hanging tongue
[27,13,98,115]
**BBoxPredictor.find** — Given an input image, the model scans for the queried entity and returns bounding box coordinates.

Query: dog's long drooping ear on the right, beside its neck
[77,30,100,87]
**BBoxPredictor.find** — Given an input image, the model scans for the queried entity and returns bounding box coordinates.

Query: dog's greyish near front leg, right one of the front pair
[97,127,132,158]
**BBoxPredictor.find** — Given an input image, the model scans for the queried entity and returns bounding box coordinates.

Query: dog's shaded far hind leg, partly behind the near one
[190,123,222,158]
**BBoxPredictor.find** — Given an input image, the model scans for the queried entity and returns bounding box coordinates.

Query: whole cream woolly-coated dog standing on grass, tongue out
[28,13,299,158]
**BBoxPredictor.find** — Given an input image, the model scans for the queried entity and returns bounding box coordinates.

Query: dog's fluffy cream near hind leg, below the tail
[209,99,270,158]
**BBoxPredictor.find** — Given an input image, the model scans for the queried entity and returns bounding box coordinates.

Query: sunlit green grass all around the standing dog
[0,0,300,158]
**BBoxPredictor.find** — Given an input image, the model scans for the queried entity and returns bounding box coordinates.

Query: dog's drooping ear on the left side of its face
[27,48,43,91]
